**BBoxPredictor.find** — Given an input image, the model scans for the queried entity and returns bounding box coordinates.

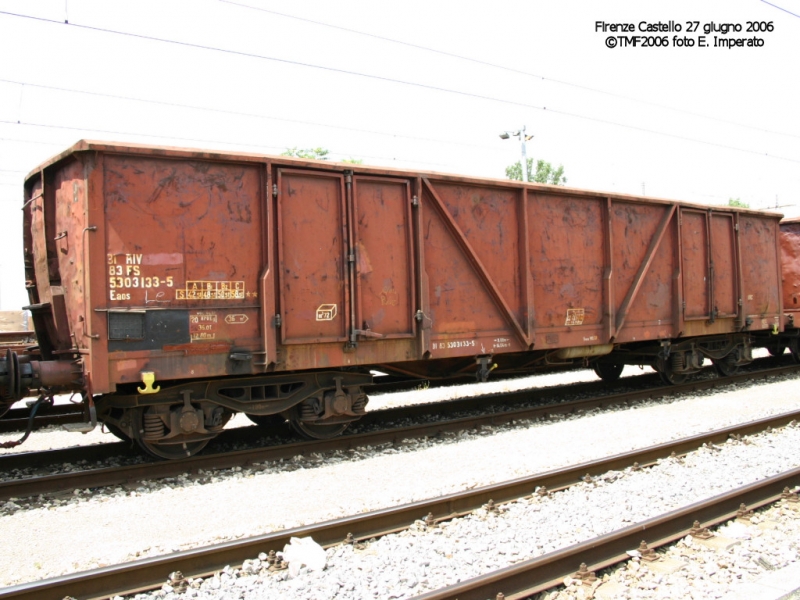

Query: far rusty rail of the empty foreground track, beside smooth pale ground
[0,411,800,600]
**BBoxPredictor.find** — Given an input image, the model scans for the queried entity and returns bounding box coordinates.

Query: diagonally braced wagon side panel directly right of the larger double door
[418,179,531,358]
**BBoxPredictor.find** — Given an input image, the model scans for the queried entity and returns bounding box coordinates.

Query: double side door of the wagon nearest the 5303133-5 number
[277,169,415,349]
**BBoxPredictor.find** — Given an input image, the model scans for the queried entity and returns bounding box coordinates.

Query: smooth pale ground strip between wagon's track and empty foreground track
[0,368,800,586]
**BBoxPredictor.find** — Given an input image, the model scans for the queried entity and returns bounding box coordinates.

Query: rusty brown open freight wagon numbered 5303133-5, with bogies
[3,141,782,457]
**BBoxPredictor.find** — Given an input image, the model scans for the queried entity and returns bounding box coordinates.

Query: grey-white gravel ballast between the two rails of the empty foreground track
[126,425,800,600]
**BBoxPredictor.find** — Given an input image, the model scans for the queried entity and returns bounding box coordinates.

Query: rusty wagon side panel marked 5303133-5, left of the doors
[100,154,266,390]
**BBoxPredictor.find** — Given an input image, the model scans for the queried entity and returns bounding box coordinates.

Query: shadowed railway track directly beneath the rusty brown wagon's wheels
[0,365,800,500]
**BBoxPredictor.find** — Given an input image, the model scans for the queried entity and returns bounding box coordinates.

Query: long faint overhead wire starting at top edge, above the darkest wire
[219,0,800,138]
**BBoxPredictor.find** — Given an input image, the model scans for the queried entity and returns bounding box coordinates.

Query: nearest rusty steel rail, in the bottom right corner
[414,467,800,600]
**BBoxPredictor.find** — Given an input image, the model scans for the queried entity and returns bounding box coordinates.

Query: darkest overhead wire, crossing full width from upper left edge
[0,11,800,163]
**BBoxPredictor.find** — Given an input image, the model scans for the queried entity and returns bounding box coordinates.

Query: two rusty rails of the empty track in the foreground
[0,411,800,600]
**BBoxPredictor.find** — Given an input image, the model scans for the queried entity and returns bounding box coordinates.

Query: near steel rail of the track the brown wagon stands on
[0,366,798,500]
